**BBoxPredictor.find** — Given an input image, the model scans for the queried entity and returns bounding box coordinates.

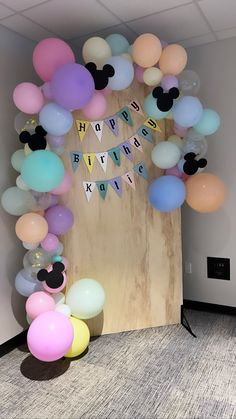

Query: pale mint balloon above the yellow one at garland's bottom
[66,278,105,319]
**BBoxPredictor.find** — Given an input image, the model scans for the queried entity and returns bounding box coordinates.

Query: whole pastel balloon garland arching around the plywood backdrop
[1,33,225,362]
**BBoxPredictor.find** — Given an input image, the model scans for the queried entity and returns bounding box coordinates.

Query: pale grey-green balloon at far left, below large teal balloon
[1,186,35,215]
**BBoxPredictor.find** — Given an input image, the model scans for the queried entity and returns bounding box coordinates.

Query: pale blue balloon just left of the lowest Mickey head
[15,269,43,297]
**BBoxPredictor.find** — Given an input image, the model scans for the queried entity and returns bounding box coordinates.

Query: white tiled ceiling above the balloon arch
[0,0,236,48]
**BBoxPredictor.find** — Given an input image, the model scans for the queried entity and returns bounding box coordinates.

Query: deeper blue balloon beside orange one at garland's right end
[148,176,186,212]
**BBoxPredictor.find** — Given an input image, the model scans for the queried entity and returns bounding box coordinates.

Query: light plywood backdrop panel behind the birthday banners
[60,84,182,335]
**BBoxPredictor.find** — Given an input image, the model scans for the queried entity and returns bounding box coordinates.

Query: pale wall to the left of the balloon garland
[0,26,36,344]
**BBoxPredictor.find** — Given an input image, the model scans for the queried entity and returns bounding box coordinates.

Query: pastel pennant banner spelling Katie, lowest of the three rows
[83,162,148,202]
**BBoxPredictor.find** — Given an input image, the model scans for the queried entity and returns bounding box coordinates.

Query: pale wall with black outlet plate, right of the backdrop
[182,38,236,307]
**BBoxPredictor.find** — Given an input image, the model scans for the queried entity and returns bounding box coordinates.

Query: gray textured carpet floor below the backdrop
[0,310,236,419]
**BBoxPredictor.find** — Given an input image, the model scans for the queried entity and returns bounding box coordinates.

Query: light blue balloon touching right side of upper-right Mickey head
[172,96,203,128]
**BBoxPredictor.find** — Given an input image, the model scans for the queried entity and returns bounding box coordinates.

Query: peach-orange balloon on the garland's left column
[15,212,48,243]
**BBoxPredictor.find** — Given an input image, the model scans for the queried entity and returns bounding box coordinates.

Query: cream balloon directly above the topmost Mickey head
[82,36,112,68]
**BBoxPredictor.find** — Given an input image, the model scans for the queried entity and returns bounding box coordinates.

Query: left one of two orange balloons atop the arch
[132,33,162,68]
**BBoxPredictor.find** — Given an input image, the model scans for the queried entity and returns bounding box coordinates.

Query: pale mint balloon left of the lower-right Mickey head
[151,141,181,169]
